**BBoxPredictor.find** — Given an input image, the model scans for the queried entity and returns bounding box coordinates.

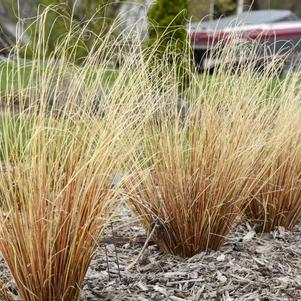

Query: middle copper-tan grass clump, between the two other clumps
[126,57,282,257]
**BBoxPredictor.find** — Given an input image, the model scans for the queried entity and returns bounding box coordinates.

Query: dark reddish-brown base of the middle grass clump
[127,190,240,257]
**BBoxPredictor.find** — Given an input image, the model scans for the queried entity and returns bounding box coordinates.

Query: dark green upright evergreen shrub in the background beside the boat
[147,0,190,92]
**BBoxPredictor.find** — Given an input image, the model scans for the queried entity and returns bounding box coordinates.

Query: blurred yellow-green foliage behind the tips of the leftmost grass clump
[23,0,122,62]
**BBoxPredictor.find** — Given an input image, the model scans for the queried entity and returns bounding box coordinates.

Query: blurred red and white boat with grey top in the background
[189,10,301,71]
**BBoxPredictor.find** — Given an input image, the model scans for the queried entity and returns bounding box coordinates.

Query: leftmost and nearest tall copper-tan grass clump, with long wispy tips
[0,5,162,301]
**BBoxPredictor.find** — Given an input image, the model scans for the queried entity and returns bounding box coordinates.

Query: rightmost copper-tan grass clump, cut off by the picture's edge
[246,95,301,232]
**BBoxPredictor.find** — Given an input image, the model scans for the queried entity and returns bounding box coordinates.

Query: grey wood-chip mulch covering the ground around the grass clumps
[0,209,301,301]
